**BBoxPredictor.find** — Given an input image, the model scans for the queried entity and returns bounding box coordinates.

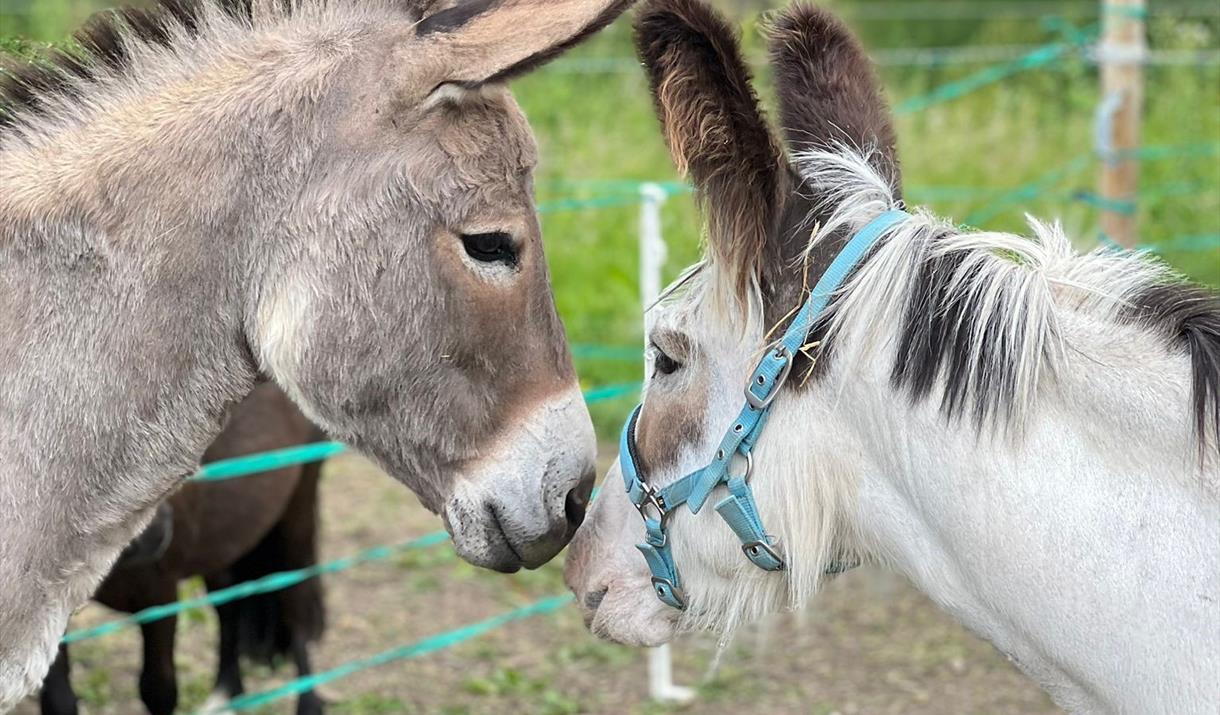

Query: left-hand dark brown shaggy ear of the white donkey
[636,0,788,294]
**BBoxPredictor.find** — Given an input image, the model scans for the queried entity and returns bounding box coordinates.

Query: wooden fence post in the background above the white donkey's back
[1097,0,1147,248]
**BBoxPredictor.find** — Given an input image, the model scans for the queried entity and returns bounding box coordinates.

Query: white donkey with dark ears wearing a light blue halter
[567,0,1220,715]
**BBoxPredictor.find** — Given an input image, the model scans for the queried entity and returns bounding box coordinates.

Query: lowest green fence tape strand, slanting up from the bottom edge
[199,594,572,715]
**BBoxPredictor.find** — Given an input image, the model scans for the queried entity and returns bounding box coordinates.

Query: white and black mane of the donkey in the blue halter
[798,148,1220,450]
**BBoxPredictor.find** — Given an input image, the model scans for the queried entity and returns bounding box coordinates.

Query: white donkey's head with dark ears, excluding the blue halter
[566,0,898,644]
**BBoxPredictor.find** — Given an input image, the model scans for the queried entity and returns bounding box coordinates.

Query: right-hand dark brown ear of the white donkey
[770,5,900,192]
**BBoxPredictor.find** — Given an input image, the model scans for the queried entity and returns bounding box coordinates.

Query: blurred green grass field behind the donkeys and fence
[0,0,1220,434]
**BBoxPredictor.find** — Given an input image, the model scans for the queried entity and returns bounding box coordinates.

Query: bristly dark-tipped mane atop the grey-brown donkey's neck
[0,0,375,149]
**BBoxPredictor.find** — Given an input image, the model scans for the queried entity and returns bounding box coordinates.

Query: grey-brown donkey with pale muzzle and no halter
[0,0,631,711]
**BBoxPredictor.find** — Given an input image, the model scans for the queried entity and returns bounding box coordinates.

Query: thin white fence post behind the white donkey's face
[639,183,694,703]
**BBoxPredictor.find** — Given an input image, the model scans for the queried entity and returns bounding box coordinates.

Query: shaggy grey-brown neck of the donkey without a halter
[0,4,351,711]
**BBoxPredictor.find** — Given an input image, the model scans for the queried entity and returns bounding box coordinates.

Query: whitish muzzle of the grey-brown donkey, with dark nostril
[444,384,597,572]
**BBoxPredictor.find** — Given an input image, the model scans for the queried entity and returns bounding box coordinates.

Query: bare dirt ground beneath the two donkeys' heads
[16,456,1059,715]
